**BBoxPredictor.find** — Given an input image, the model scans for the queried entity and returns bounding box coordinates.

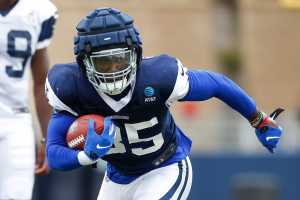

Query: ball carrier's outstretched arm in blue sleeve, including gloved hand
[181,70,283,153]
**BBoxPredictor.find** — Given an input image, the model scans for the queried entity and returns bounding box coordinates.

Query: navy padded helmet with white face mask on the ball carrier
[74,8,142,95]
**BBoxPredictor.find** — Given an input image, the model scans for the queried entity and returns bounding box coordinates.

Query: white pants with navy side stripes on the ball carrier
[97,157,193,200]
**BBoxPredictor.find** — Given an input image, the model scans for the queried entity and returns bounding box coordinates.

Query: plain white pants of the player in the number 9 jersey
[0,113,35,200]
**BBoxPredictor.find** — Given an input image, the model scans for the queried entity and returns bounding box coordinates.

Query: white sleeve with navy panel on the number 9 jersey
[35,0,58,49]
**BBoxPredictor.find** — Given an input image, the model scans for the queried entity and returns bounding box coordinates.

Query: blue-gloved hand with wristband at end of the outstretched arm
[255,108,284,153]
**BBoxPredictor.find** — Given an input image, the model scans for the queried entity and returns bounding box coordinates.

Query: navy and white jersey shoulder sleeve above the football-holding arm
[45,65,78,116]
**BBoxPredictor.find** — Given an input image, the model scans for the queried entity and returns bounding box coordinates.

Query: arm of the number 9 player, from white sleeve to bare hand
[31,1,58,175]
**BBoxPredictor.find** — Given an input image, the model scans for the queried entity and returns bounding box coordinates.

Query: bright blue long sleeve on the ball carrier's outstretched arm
[181,70,256,120]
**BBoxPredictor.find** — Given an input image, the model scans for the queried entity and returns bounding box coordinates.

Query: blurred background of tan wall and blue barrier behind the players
[34,0,300,200]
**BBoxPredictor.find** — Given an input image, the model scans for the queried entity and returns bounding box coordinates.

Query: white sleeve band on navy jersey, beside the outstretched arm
[166,59,189,106]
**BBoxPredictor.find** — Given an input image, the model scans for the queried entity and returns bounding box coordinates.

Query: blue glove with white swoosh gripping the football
[83,117,116,160]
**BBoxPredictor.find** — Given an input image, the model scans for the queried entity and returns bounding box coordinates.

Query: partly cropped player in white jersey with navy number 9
[0,0,57,200]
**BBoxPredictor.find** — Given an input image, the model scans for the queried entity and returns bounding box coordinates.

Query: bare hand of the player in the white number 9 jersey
[35,141,50,175]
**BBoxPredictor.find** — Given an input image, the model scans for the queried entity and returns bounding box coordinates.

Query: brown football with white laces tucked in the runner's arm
[66,114,104,150]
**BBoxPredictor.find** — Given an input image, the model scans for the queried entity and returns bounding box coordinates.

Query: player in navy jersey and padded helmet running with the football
[46,8,282,200]
